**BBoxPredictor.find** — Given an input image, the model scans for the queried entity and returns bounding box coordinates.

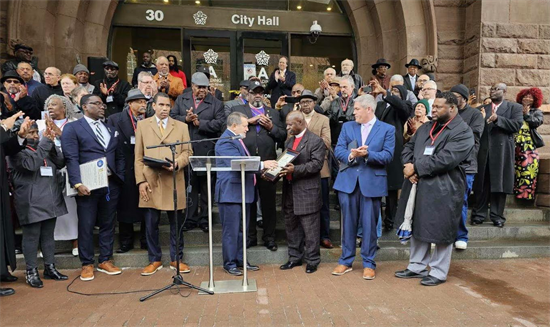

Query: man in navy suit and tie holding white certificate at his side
[61,95,125,281]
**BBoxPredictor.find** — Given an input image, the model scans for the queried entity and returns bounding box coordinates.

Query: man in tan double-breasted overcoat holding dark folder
[135,92,193,276]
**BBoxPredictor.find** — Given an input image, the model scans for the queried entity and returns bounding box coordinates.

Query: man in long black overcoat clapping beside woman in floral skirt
[471,83,523,227]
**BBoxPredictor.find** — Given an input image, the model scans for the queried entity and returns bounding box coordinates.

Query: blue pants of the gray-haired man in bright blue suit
[338,185,380,269]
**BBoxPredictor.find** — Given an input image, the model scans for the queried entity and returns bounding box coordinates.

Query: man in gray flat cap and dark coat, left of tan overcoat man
[107,89,147,253]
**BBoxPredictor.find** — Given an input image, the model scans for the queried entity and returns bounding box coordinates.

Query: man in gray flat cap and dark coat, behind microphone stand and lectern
[170,73,225,233]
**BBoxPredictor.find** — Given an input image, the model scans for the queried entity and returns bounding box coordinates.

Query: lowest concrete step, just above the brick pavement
[17,237,550,274]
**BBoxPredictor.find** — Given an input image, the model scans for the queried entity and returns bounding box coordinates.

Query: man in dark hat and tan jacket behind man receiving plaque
[300,90,334,249]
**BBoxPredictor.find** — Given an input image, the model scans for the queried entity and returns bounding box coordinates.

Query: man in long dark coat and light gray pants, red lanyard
[395,92,474,286]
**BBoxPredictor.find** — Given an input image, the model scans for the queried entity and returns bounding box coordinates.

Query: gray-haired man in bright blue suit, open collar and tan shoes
[332,94,395,279]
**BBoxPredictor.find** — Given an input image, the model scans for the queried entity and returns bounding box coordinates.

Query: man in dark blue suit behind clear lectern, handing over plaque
[215,112,277,276]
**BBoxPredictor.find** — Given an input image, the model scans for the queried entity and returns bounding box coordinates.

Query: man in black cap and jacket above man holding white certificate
[93,60,132,118]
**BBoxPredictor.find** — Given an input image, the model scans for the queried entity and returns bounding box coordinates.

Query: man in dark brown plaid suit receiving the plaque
[280,110,327,274]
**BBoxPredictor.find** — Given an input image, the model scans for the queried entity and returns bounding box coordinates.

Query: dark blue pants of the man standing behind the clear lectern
[218,203,251,270]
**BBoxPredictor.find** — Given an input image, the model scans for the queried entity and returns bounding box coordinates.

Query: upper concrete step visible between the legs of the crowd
[50,221,550,253]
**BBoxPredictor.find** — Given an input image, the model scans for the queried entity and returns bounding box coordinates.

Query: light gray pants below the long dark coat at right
[407,236,453,280]
